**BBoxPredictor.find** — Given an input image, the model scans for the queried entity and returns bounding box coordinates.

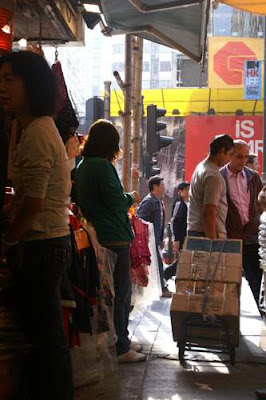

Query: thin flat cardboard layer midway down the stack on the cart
[176,279,239,297]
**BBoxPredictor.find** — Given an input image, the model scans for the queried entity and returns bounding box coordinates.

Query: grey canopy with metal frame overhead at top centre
[101,0,210,62]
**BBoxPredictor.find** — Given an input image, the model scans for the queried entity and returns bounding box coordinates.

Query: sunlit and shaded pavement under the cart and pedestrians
[75,279,266,400]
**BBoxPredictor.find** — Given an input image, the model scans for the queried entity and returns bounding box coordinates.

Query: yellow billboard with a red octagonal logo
[208,36,263,89]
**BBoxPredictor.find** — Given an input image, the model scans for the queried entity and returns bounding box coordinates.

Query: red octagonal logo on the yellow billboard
[213,41,257,85]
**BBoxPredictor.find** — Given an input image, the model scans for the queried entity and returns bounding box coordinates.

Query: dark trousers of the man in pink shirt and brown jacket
[243,244,262,304]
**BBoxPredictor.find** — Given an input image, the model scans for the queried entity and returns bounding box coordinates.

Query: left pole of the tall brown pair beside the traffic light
[122,35,132,191]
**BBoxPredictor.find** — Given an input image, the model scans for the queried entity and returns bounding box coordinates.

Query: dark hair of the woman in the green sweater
[81,119,120,161]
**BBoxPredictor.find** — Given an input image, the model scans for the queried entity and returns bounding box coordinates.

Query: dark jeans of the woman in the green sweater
[108,247,131,356]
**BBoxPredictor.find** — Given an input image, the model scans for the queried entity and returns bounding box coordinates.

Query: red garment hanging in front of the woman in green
[130,215,151,287]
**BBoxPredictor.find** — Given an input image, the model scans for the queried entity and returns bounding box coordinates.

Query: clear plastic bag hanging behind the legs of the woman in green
[71,220,117,387]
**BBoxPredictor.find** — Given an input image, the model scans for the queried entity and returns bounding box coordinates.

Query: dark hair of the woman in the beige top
[0,51,57,117]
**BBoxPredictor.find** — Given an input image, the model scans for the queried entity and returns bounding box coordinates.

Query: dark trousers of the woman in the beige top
[18,236,73,400]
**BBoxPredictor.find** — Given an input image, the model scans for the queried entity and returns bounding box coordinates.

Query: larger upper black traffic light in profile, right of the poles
[146,105,173,154]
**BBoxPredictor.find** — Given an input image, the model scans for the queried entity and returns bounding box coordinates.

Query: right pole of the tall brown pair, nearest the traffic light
[131,37,143,191]
